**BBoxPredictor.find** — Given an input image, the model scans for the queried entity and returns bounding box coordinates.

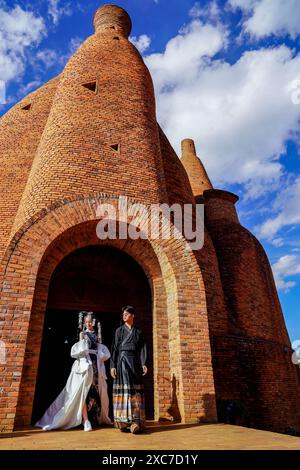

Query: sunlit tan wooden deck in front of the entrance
[0,423,300,450]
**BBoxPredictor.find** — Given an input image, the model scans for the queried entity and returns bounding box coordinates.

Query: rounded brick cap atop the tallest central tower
[94,5,132,38]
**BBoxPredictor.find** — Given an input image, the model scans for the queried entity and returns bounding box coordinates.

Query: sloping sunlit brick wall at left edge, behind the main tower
[0,77,59,260]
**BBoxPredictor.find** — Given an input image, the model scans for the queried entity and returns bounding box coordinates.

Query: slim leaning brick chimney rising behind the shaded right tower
[181,139,213,197]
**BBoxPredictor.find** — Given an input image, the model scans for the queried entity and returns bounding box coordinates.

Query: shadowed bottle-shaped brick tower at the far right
[204,190,300,432]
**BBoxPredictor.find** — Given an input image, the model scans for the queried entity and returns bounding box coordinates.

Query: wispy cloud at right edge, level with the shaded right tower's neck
[257,177,300,241]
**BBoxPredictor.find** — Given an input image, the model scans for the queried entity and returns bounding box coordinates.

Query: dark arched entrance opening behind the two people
[32,245,154,424]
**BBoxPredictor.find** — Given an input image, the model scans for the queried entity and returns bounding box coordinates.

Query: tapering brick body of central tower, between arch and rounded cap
[14,29,167,235]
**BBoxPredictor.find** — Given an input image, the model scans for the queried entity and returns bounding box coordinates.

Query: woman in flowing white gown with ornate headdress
[35,312,111,431]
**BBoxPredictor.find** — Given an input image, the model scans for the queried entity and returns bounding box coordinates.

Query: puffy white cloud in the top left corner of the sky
[0,6,46,81]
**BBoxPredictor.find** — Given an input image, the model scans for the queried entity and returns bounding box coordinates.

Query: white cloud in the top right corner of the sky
[229,0,300,39]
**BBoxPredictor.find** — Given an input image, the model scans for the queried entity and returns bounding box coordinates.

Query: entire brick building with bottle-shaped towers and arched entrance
[0,5,300,432]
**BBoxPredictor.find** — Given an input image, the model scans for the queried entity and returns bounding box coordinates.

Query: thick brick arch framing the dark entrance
[0,195,216,430]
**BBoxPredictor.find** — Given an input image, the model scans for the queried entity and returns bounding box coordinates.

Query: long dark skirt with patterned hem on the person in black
[113,351,145,428]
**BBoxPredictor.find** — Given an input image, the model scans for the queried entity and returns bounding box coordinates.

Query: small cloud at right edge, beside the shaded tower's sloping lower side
[272,255,300,292]
